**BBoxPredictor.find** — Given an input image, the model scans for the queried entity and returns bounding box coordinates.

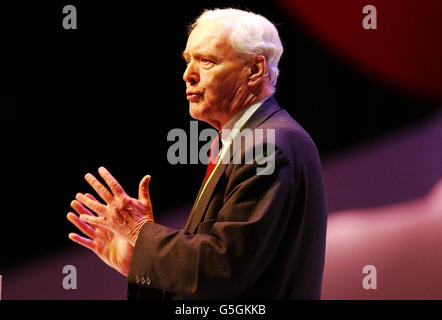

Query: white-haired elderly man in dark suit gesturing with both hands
[67,9,327,299]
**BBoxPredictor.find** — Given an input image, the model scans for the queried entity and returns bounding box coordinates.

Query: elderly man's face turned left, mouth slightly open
[183,23,248,129]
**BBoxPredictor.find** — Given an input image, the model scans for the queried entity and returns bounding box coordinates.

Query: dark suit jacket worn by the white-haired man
[127,97,327,299]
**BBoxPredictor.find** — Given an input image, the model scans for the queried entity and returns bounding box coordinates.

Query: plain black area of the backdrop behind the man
[0,0,437,267]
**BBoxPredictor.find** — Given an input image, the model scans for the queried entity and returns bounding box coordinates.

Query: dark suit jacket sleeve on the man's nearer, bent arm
[128,147,296,299]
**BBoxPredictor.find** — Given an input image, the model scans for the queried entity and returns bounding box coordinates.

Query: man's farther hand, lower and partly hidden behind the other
[66,194,134,276]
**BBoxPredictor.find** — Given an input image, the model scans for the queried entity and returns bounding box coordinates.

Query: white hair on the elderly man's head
[189,8,283,91]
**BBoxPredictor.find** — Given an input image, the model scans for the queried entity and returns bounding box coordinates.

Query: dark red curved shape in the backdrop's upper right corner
[280,0,442,100]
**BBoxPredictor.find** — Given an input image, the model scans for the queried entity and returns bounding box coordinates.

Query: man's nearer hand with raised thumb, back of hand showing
[75,167,154,246]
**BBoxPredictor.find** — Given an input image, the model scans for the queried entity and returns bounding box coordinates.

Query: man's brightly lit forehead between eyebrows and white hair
[185,22,232,54]
